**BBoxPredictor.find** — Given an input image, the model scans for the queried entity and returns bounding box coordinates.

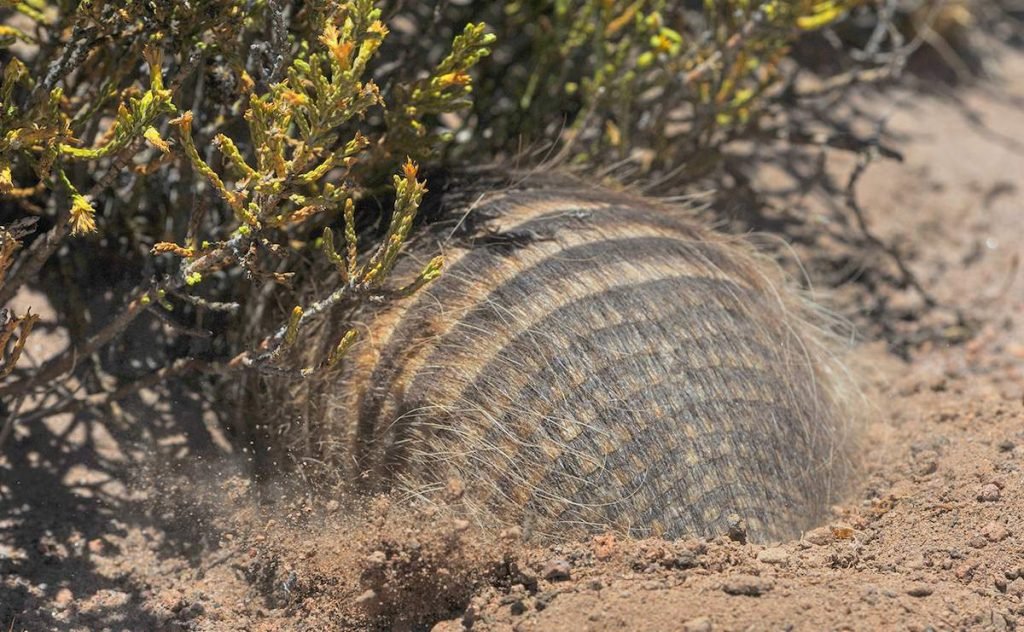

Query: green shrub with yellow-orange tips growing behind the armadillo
[0,0,942,448]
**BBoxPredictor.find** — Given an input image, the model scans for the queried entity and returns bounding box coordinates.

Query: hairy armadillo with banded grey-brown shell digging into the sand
[299,176,848,540]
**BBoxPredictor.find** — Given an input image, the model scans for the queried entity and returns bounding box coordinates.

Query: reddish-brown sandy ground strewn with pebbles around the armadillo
[0,40,1024,632]
